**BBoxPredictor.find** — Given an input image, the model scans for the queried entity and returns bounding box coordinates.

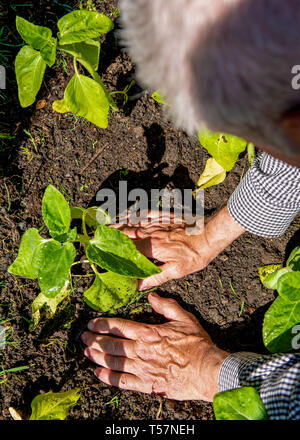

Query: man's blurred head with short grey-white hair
[121,0,300,166]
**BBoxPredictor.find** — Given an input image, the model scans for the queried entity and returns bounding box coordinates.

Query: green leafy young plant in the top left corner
[15,10,118,128]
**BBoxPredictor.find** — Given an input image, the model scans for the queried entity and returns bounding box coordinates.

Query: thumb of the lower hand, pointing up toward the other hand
[148,292,196,324]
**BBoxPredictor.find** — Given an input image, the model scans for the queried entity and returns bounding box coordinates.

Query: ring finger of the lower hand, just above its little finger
[84,348,137,373]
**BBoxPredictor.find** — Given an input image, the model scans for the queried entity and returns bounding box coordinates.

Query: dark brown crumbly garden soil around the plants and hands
[0,0,298,420]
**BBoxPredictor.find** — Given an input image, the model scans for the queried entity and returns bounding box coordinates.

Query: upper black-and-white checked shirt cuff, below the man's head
[228,153,300,237]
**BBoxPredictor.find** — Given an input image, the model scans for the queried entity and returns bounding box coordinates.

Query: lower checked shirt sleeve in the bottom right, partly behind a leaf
[219,352,300,420]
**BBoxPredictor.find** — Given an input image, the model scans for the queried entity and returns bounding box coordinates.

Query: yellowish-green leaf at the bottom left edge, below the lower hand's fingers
[29,388,80,420]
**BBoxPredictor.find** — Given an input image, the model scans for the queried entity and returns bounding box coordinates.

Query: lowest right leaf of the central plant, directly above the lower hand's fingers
[84,272,137,313]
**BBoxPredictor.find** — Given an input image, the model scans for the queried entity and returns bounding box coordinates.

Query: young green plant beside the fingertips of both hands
[8,185,161,330]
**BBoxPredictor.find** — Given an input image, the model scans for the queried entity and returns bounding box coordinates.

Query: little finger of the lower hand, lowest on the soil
[95,368,152,394]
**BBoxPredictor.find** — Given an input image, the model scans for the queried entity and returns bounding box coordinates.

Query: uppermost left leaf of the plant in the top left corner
[16,17,52,50]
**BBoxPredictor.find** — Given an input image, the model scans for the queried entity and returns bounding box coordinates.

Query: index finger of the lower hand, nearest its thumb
[88,318,147,340]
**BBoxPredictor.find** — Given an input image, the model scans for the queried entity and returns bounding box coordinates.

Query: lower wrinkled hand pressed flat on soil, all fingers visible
[82,293,229,401]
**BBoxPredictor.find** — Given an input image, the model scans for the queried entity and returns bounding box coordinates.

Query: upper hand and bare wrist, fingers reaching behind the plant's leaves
[112,207,245,290]
